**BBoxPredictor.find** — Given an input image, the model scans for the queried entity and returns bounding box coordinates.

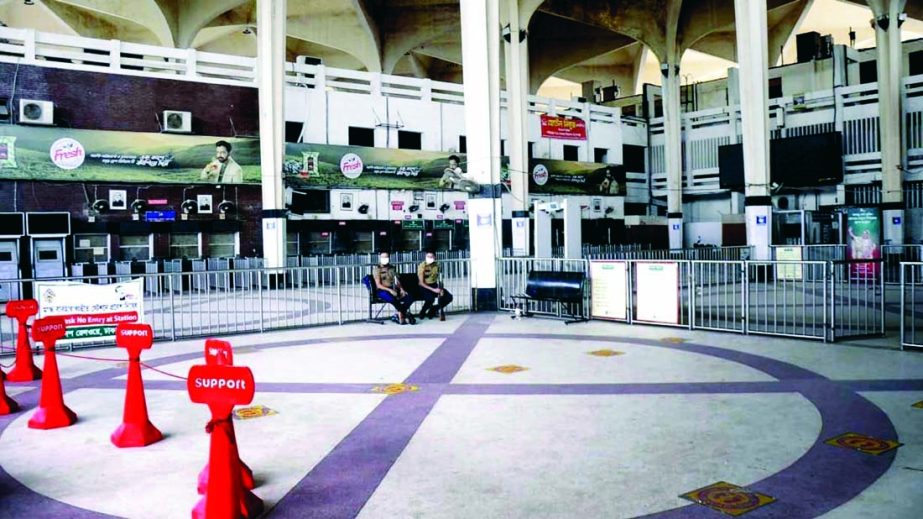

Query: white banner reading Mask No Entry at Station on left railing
[35,278,144,344]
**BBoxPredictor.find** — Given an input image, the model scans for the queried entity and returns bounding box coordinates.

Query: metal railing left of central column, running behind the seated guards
[0,260,472,353]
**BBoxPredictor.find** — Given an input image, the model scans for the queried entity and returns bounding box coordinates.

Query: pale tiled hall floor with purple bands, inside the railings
[0,314,923,518]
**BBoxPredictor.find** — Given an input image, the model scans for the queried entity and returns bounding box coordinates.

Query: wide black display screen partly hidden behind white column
[718,132,843,191]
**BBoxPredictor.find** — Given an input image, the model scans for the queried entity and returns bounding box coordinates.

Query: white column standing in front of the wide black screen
[734,0,772,260]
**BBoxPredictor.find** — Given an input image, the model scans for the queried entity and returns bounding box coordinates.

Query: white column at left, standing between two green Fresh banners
[257,0,286,268]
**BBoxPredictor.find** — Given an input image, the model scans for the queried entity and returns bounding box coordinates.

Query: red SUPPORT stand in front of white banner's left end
[29,317,77,429]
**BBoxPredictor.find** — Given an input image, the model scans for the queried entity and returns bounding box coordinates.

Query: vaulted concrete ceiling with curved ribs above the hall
[0,0,923,92]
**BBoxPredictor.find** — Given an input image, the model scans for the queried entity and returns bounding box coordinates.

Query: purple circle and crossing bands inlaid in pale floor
[0,314,900,518]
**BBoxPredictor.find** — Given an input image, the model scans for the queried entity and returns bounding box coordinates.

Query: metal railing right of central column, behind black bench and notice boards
[497,258,888,341]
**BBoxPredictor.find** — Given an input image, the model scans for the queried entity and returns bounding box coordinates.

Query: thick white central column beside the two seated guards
[461,0,502,310]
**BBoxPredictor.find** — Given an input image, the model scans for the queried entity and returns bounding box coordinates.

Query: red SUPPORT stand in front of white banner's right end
[110,323,163,447]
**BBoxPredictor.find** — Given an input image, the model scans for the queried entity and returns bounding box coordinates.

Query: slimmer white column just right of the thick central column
[504,0,531,256]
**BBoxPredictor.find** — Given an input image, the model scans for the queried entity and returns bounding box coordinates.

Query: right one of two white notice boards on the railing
[635,262,679,324]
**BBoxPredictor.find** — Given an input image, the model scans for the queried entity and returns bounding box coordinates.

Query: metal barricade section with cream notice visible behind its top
[744,261,828,340]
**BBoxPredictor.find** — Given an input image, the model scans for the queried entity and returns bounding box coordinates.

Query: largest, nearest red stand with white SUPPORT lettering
[187,365,263,519]
